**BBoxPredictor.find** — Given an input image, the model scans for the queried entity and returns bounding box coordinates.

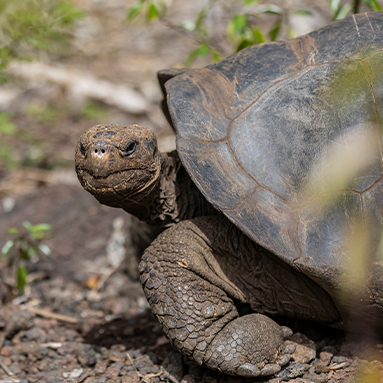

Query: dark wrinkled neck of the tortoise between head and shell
[119,152,218,227]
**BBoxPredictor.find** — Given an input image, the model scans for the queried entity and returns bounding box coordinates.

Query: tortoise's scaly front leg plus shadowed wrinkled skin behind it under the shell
[139,216,339,377]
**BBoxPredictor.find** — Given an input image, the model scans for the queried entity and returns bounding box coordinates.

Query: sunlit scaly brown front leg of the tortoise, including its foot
[140,216,290,377]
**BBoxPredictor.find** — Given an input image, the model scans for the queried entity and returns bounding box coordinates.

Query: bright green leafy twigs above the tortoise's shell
[127,0,382,66]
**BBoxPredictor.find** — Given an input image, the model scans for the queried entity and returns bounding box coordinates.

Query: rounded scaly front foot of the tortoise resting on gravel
[204,314,294,377]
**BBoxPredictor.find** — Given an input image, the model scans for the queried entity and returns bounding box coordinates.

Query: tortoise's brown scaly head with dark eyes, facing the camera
[75,125,161,211]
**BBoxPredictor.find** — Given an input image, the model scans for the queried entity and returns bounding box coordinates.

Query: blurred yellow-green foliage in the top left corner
[0,0,85,79]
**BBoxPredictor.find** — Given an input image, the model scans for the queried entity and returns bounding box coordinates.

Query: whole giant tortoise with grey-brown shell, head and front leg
[76,12,383,377]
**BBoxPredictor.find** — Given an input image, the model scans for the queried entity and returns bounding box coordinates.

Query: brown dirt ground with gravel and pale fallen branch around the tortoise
[0,0,383,383]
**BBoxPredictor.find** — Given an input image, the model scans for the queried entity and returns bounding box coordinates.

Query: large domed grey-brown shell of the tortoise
[165,12,383,284]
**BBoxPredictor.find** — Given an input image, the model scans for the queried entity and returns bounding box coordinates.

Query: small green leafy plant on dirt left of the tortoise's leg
[1,221,52,295]
